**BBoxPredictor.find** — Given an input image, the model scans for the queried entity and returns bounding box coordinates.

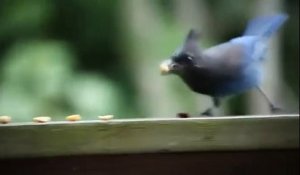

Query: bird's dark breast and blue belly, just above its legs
[181,66,261,97]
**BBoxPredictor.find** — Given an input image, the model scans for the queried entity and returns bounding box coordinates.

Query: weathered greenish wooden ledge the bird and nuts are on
[0,114,299,158]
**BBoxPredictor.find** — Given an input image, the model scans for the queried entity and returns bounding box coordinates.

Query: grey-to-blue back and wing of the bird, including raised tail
[204,14,288,65]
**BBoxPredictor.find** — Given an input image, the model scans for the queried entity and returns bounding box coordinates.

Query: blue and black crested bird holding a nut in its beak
[159,13,289,116]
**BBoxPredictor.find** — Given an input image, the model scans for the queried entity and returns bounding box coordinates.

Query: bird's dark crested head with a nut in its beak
[160,29,200,75]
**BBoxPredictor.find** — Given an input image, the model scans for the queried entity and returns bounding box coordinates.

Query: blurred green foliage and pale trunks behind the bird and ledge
[0,0,299,121]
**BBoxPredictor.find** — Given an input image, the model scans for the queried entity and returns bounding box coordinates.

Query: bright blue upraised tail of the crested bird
[244,14,288,38]
